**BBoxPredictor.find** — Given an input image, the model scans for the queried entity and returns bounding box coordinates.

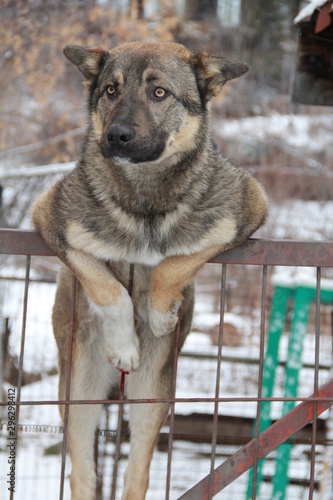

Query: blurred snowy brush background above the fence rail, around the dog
[0,0,333,234]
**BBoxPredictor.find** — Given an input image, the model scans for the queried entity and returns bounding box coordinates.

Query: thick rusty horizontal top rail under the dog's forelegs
[0,229,333,267]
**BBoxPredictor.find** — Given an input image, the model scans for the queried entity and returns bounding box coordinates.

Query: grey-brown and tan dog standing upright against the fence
[32,42,268,500]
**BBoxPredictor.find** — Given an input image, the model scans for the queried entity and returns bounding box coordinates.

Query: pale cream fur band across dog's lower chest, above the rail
[66,186,237,266]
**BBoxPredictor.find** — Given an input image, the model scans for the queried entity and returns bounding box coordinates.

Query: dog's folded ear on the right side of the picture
[194,52,249,101]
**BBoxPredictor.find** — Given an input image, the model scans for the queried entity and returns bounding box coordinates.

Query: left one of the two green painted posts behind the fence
[246,286,294,499]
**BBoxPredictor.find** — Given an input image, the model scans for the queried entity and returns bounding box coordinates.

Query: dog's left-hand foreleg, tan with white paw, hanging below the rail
[66,249,139,371]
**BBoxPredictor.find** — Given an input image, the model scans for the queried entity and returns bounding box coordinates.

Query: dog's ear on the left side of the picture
[64,45,108,86]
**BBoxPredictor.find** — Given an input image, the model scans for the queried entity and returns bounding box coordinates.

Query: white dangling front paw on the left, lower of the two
[105,334,140,372]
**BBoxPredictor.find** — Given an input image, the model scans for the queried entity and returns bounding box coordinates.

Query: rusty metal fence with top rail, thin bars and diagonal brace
[0,230,333,500]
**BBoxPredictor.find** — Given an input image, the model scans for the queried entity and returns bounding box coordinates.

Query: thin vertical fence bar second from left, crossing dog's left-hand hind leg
[59,276,76,500]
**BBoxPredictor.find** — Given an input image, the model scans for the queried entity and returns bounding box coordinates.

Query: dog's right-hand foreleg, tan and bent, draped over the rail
[149,246,220,337]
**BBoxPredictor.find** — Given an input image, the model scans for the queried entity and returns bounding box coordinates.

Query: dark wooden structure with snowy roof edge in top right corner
[293,0,333,106]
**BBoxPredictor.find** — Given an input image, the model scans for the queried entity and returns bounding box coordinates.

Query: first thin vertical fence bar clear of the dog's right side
[209,264,227,500]
